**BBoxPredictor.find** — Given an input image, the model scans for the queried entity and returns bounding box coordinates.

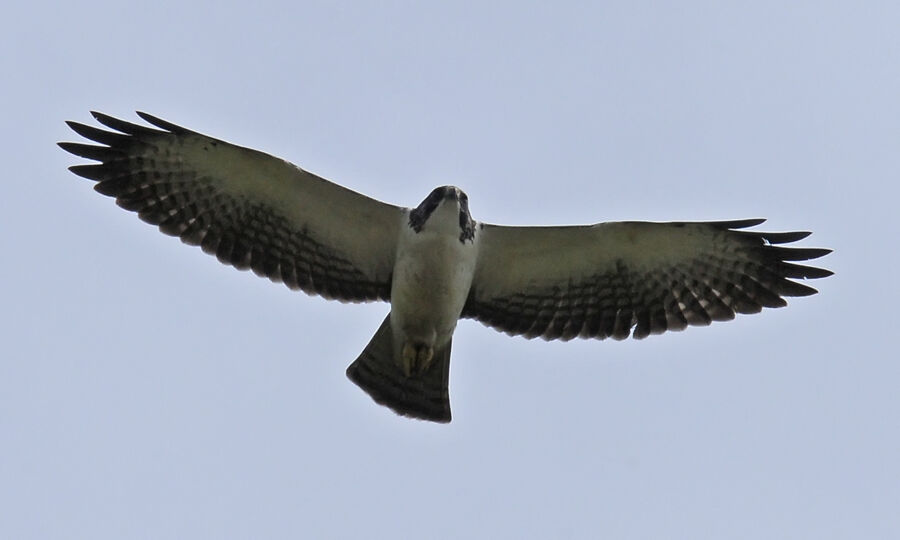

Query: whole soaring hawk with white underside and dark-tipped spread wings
[59,112,831,422]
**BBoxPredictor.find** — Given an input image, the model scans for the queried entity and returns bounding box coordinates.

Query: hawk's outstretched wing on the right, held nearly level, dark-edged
[462,219,831,340]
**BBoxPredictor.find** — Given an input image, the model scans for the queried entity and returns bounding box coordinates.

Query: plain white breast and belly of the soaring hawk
[391,229,477,347]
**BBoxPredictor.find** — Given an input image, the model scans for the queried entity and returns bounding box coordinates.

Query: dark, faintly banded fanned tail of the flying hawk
[347,314,450,422]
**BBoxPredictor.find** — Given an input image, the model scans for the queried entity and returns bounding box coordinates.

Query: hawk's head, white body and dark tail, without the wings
[347,186,478,422]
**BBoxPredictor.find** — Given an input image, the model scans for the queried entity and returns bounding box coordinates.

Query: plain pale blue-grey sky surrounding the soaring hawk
[0,0,900,540]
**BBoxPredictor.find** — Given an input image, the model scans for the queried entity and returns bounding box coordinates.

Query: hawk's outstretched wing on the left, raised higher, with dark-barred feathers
[59,113,403,302]
